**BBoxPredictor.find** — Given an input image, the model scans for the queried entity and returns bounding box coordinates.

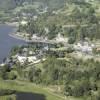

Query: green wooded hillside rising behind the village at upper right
[16,0,100,41]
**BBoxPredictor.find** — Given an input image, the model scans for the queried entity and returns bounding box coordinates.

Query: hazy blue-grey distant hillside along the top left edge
[0,0,64,10]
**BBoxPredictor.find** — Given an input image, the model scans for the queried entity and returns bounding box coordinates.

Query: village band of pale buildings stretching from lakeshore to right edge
[1,36,100,66]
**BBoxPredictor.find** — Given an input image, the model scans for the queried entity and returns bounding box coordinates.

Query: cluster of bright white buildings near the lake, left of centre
[13,46,48,64]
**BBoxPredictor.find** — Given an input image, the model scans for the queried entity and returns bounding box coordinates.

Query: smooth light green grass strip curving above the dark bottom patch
[0,80,64,100]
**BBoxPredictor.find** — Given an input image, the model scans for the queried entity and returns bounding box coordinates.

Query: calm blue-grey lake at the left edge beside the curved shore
[0,25,25,63]
